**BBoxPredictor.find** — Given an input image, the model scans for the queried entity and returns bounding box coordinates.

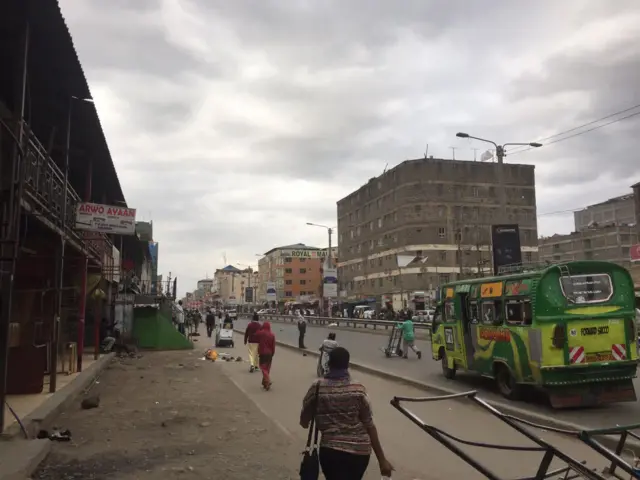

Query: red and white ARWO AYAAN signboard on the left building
[76,202,136,235]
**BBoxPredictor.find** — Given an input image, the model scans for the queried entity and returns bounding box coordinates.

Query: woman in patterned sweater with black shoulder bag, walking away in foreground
[300,347,393,480]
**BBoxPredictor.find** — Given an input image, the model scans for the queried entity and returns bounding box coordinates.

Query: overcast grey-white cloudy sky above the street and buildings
[60,0,640,292]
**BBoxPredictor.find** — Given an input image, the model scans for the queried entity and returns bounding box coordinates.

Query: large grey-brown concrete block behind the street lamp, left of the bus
[338,158,538,306]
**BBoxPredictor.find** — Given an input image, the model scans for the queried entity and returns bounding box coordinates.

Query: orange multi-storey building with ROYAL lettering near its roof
[258,243,327,302]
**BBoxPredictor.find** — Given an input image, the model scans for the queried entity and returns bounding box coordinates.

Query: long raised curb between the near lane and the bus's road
[234,329,640,455]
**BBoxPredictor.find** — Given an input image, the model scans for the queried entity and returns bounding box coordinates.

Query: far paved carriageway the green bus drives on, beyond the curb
[236,320,640,427]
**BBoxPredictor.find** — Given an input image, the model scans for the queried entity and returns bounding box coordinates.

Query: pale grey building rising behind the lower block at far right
[573,193,636,232]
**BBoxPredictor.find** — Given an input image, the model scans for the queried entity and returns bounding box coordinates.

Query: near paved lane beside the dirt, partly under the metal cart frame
[214,329,604,480]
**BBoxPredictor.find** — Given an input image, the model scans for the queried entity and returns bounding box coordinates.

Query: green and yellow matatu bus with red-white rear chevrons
[431,261,638,408]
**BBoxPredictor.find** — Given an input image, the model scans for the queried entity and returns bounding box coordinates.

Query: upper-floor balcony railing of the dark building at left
[24,123,112,263]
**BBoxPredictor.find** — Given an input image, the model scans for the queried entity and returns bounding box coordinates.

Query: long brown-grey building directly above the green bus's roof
[539,225,638,268]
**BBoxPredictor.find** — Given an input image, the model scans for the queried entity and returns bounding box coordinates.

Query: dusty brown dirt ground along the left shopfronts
[33,350,300,480]
